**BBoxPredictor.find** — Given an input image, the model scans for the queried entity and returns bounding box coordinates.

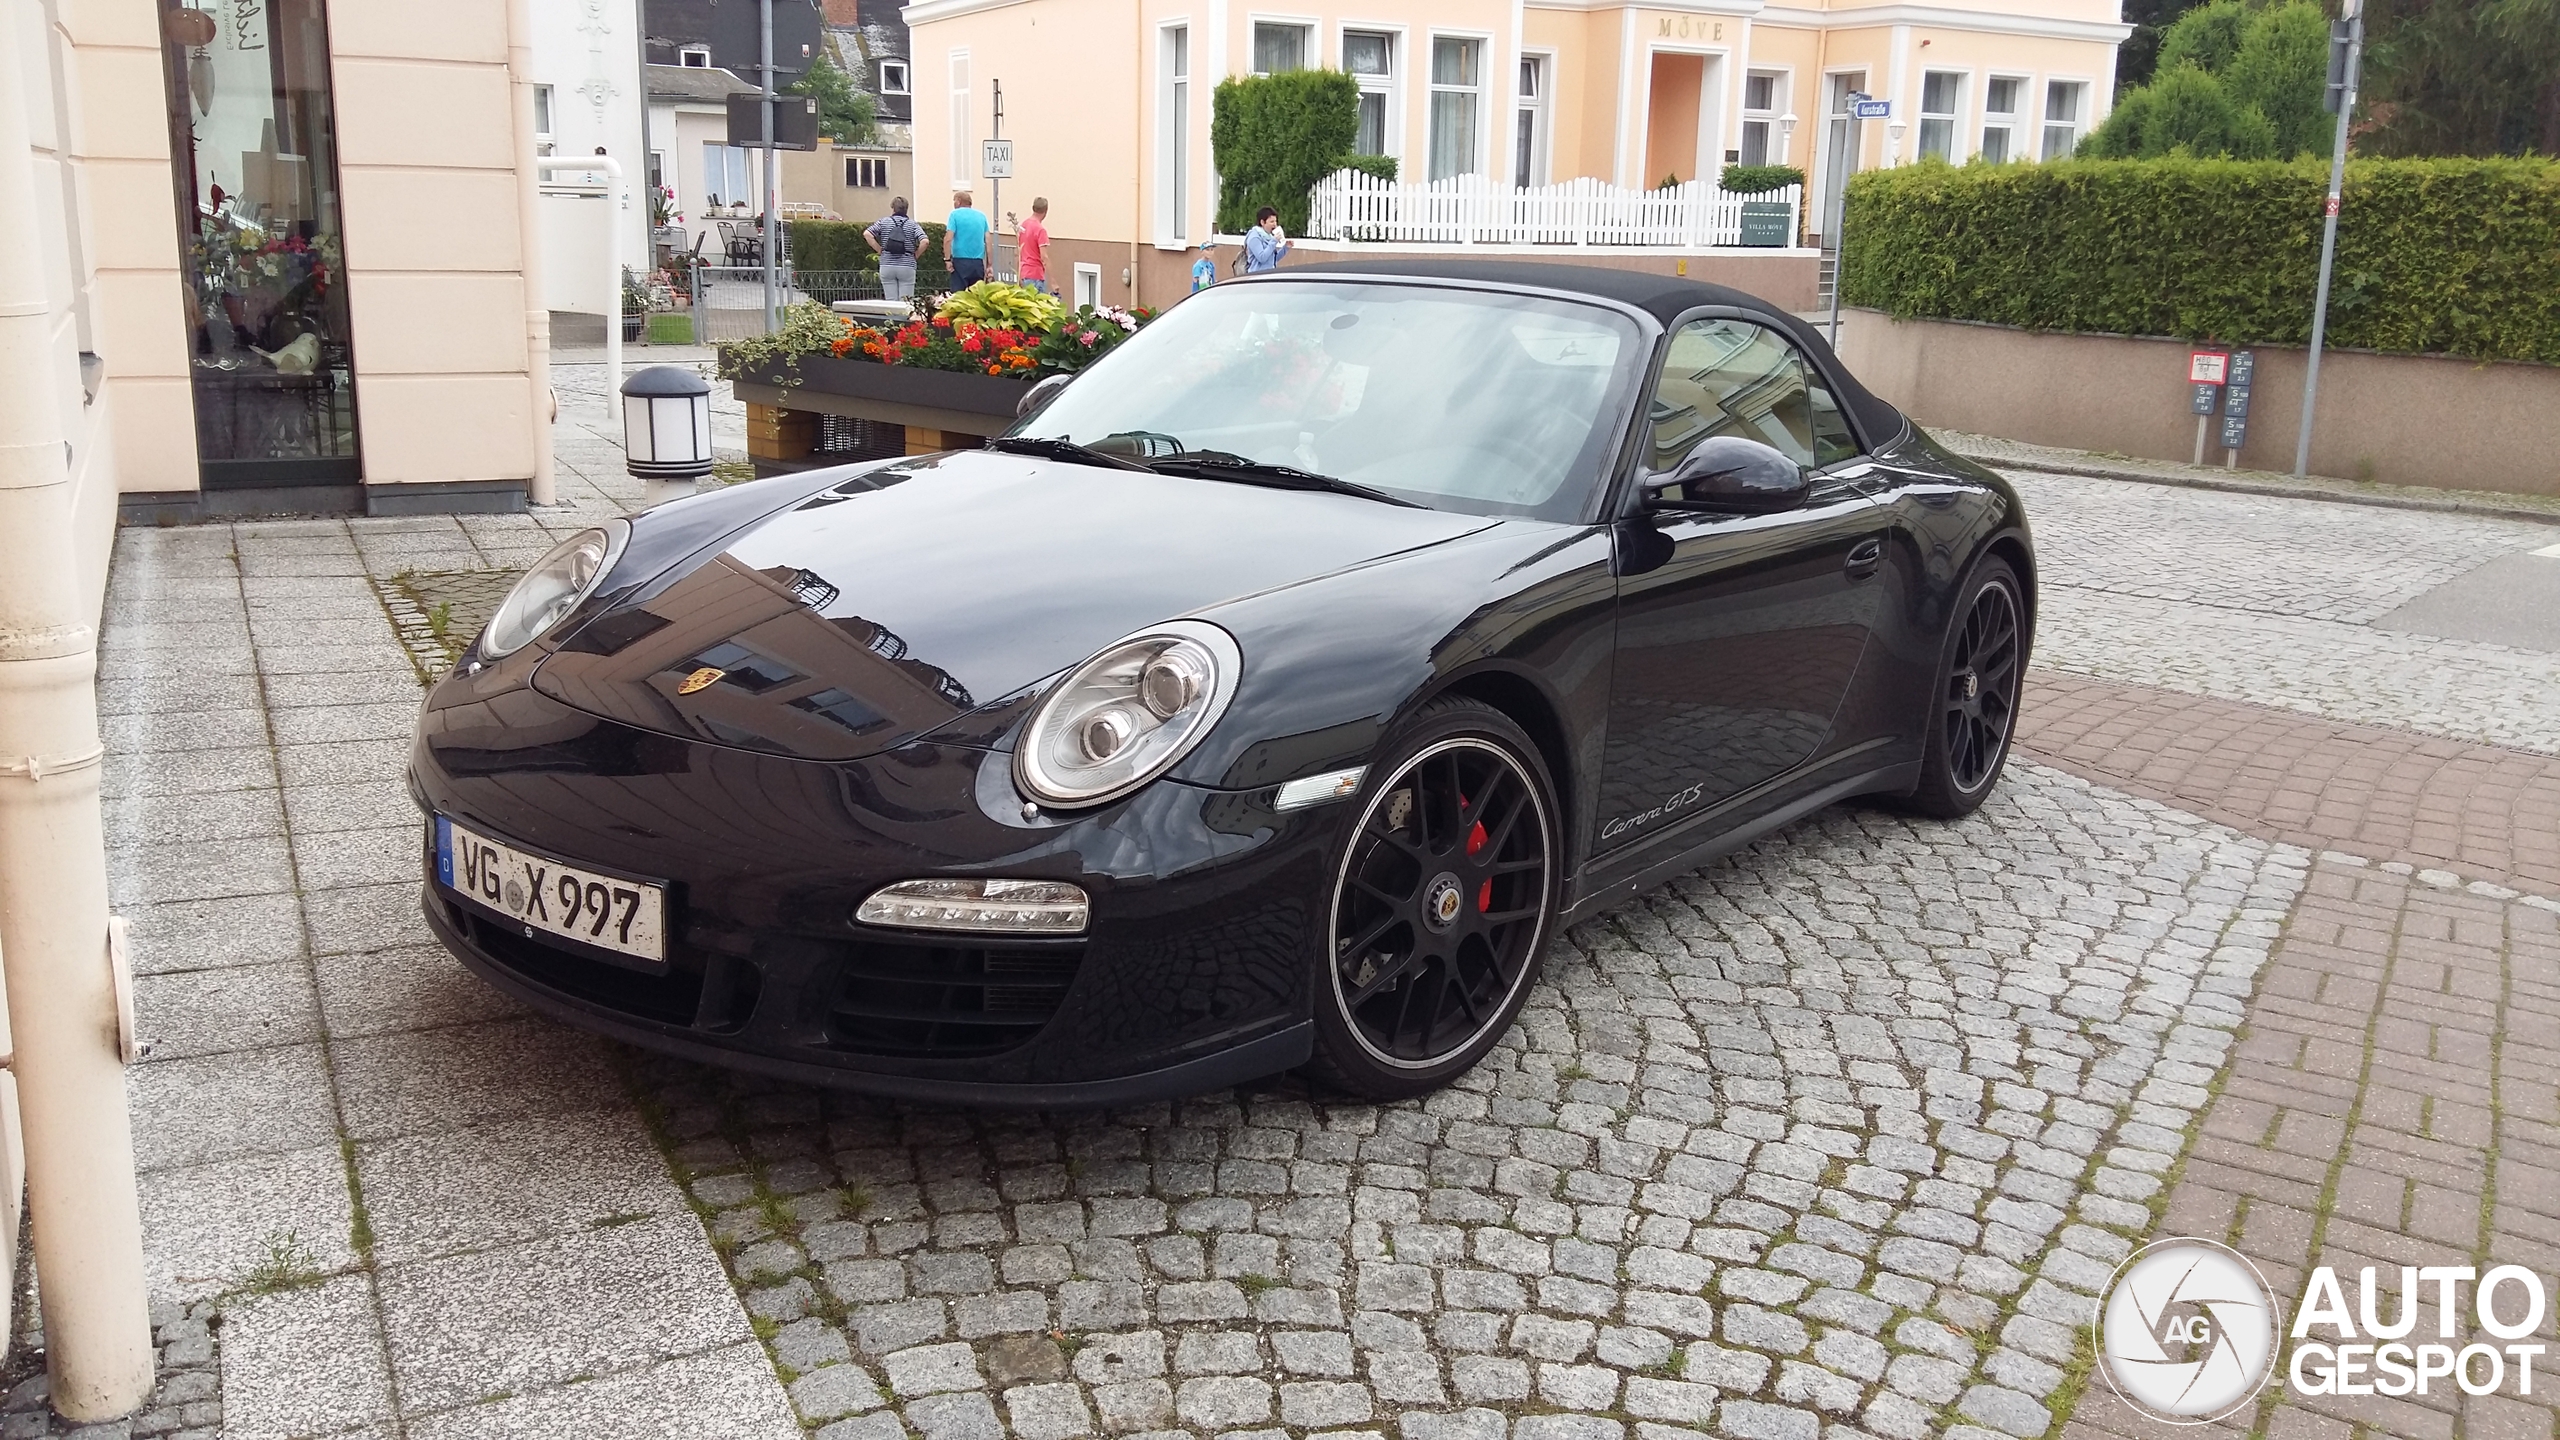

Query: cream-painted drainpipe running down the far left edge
[0,8,151,1420]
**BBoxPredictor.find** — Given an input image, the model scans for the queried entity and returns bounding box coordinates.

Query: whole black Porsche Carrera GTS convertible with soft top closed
[410,264,2035,1104]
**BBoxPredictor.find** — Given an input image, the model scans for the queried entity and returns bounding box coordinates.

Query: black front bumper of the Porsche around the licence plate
[410,676,1349,1107]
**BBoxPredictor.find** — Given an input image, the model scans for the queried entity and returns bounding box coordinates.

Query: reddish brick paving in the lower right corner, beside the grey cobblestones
[2063,853,2560,1440]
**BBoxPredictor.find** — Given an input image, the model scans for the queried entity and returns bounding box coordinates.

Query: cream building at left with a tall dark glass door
[20,0,573,597]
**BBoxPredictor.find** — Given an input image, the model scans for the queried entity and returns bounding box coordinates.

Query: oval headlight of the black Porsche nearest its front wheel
[1014,620,1244,805]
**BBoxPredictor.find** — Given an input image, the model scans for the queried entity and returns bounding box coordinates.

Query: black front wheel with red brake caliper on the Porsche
[1308,700,1562,1099]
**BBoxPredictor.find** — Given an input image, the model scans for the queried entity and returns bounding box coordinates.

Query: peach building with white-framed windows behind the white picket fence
[906,0,2130,302]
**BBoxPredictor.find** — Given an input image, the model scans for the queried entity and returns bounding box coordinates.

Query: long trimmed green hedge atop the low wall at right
[1841,159,2560,364]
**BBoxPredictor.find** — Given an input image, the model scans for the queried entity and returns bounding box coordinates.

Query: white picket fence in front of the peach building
[1308,169,1805,249]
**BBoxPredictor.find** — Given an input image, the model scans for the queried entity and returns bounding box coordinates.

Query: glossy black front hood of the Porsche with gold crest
[532,451,1495,761]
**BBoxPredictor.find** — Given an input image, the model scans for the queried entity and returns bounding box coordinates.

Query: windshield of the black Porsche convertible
[1014,279,1644,520]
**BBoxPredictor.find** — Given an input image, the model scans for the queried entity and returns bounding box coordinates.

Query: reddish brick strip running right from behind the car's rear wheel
[2017,671,2560,889]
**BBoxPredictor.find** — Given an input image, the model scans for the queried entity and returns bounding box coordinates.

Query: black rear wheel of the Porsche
[1902,556,2028,820]
